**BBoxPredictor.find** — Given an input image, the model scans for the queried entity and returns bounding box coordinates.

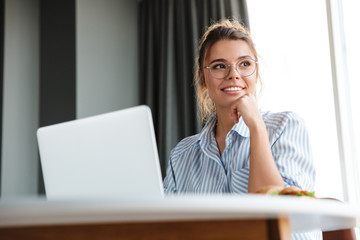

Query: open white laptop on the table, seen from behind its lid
[37,106,164,200]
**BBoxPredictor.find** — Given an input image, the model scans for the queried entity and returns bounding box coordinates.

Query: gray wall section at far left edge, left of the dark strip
[1,0,39,197]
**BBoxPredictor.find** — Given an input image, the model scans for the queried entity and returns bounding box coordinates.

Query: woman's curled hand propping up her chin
[231,94,263,130]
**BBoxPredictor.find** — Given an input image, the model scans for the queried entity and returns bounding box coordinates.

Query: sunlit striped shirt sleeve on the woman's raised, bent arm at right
[271,113,315,191]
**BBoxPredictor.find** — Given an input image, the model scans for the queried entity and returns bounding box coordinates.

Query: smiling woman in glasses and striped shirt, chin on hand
[164,20,315,239]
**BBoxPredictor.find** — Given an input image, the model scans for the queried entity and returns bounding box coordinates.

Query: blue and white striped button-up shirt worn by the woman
[164,112,321,239]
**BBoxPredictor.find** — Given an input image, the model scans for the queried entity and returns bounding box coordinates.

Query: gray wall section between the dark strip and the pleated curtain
[76,0,139,118]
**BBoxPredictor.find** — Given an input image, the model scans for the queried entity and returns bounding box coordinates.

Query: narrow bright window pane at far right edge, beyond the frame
[327,0,360,203]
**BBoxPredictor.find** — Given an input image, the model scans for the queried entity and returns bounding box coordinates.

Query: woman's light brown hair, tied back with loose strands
[194,19,259,123]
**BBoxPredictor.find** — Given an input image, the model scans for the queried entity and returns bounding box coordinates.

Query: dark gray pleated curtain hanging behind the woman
[139,0,249,177]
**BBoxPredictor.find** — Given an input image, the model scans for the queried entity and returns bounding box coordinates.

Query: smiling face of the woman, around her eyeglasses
[203,40,257,110]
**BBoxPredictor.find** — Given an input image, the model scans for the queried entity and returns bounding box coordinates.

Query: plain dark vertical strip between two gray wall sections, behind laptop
[39,0,76,194]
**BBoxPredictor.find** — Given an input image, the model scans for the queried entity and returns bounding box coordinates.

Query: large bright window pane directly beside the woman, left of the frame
[248,0,344,200]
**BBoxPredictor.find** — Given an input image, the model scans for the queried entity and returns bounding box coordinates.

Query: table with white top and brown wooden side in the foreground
[0,195,360,240]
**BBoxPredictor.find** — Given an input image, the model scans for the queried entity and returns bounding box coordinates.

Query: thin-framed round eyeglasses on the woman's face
[204,57,257,79]
